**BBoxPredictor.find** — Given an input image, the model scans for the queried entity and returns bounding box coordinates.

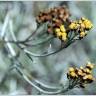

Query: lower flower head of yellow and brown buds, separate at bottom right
[67,62,95,88]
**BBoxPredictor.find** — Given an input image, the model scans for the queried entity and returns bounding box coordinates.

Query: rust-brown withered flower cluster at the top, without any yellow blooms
[36,6,70,25]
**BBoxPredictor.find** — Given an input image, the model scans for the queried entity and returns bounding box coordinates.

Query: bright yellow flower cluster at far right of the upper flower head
[69,17,93,38]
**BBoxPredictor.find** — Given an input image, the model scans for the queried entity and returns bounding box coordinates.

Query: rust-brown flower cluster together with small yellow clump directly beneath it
[37,6,70,41]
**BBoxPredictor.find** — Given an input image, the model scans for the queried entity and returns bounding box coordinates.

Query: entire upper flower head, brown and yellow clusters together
[36,7,93,42]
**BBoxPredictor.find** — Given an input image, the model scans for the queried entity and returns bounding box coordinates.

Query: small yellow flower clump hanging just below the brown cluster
[55,25,67,41]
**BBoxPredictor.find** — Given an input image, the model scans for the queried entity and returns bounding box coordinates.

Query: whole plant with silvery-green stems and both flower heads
[0,7,95,94]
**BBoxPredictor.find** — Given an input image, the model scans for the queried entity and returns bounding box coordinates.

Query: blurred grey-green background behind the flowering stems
[0,1,96,95]
